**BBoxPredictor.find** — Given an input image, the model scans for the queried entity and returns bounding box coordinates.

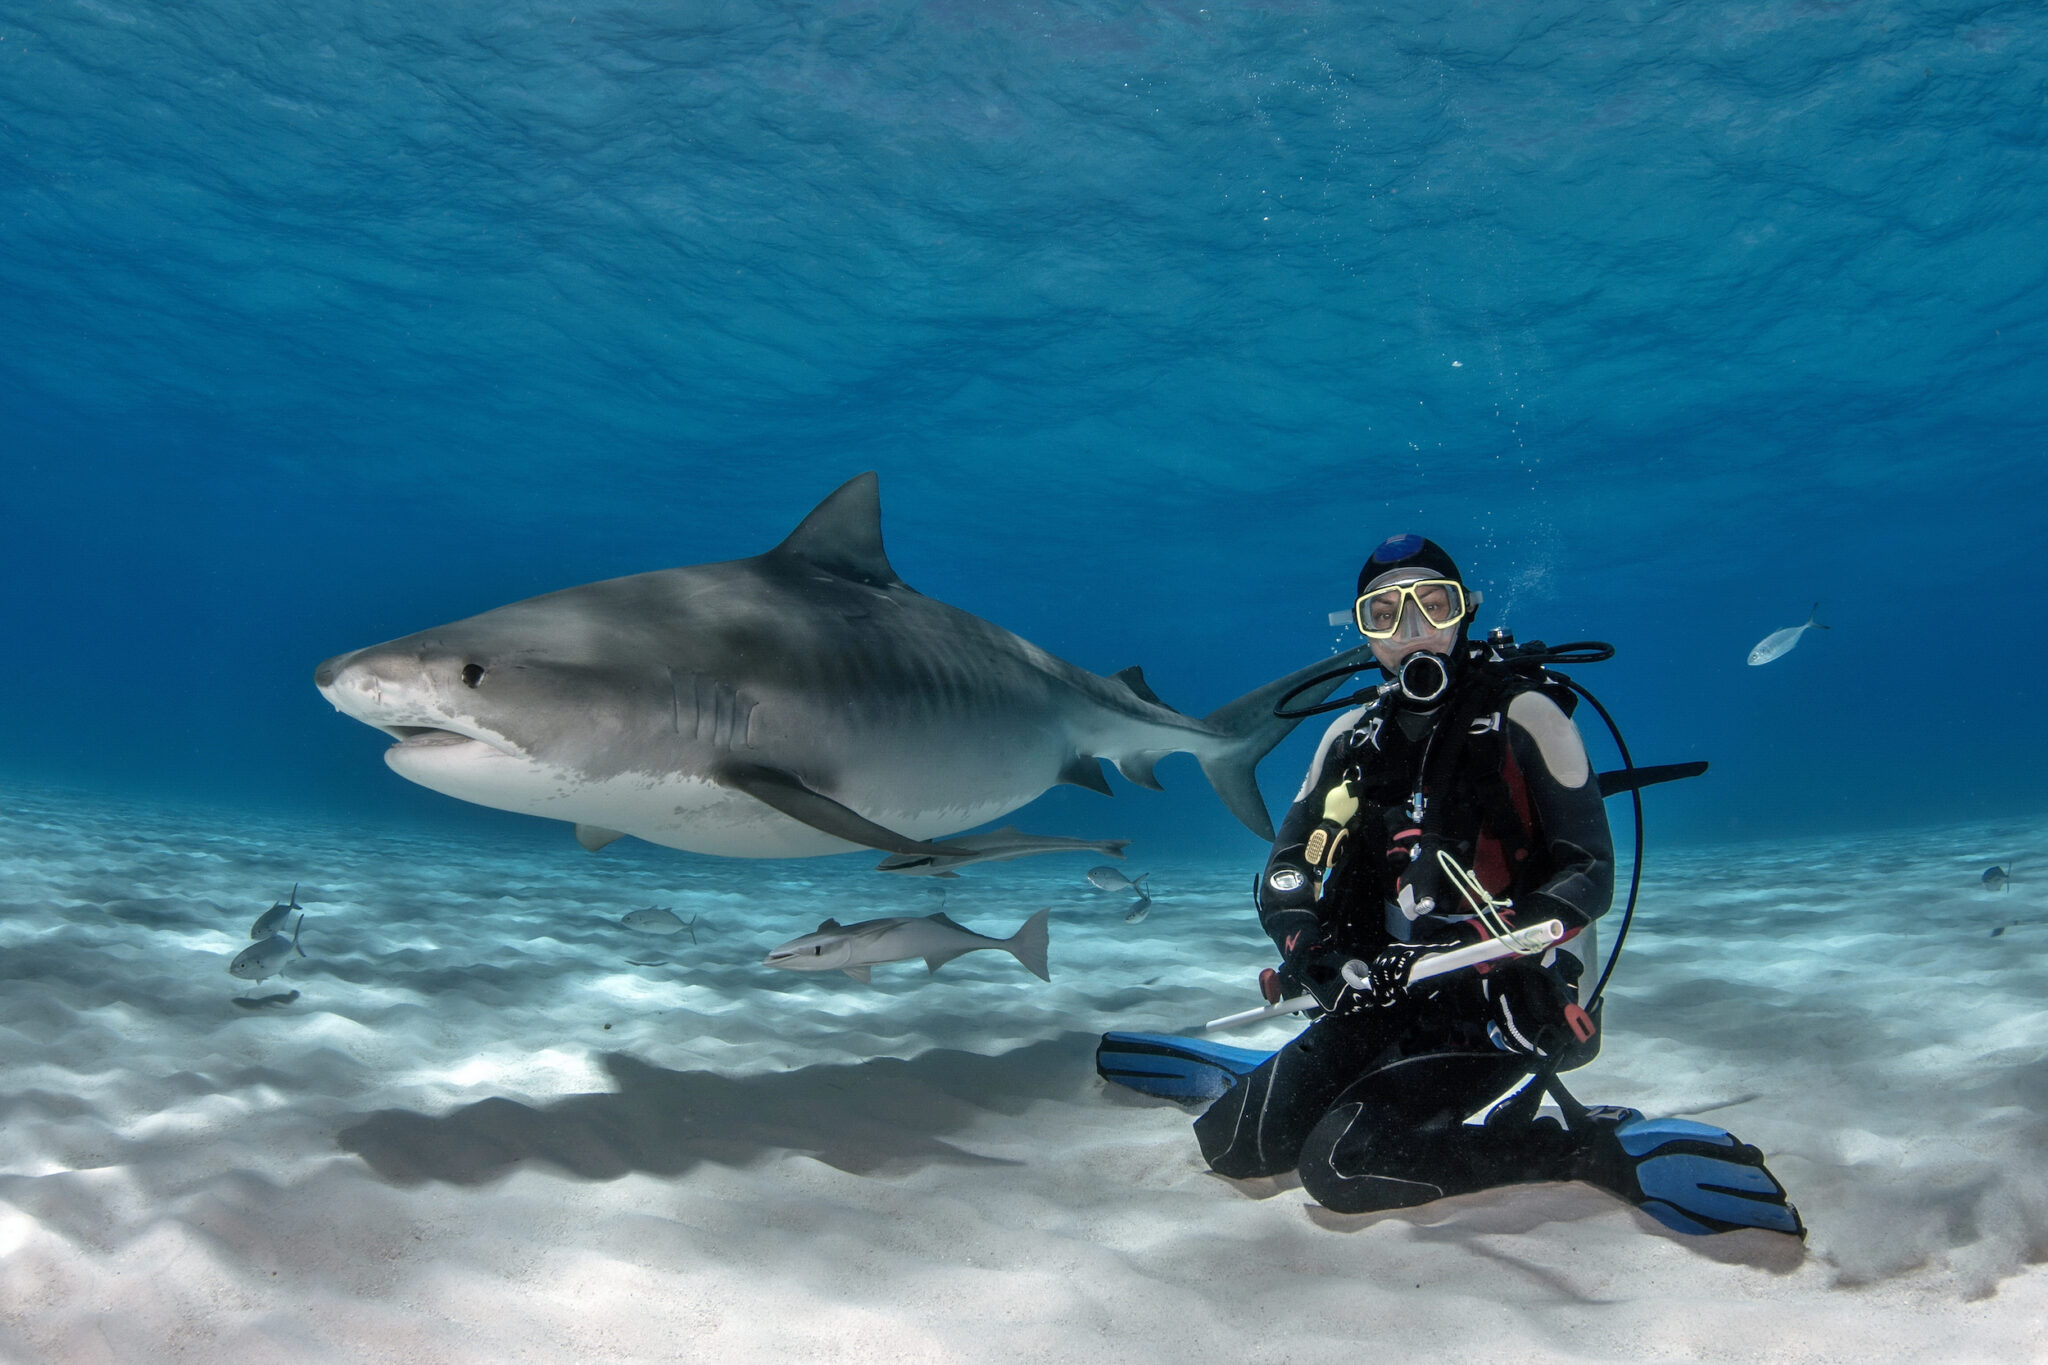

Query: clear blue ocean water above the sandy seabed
[0,0,2048,868]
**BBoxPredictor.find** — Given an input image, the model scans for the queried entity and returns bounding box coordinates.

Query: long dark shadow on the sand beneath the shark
[338,1033,1096,1185]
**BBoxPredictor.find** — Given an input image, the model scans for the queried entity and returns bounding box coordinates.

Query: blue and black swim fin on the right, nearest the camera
[1573,1105,1806,1236]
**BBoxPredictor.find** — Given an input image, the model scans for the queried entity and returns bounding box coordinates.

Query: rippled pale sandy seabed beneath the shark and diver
[0,777,2048,1365]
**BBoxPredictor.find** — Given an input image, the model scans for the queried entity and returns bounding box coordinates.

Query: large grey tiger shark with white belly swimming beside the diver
[313,473,1364,857]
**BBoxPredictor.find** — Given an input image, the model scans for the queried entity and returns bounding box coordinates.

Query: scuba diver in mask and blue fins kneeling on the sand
[1098,534,1804,1236]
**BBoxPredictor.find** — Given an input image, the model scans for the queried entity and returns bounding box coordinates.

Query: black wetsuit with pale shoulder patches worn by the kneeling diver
[1194,663,1614,1212]
